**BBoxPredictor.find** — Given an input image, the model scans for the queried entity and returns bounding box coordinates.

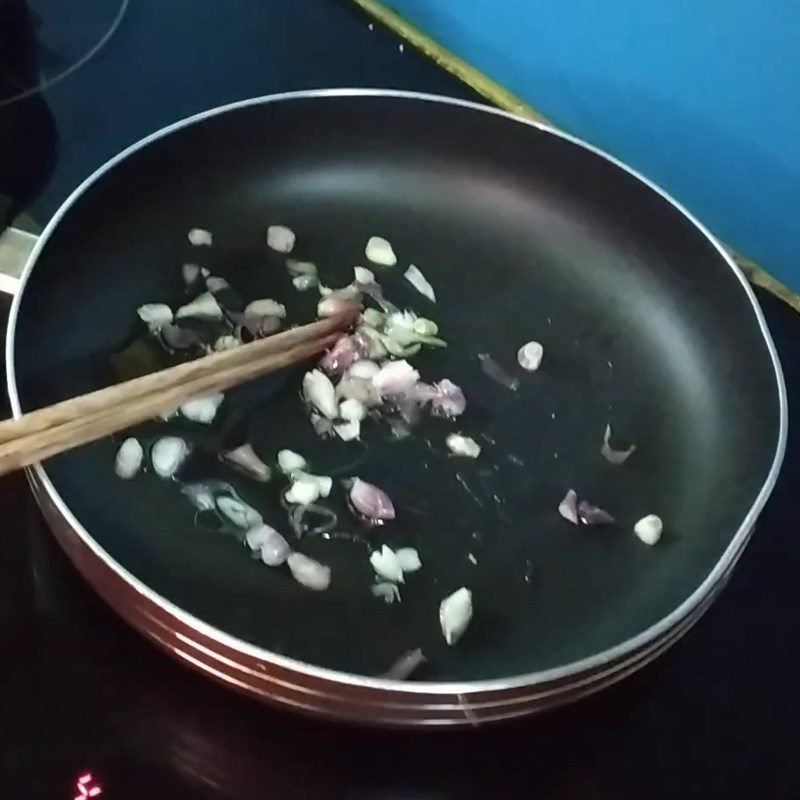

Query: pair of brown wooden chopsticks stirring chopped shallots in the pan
[0,312,357,475]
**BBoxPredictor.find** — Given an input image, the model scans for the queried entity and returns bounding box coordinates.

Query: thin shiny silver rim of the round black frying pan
[5,88,788,696]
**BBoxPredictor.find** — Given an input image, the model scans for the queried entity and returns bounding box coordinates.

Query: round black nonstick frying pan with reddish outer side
[6,90,787,725]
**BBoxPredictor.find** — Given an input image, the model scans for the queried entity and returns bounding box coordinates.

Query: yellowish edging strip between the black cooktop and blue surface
[350,0,800,313]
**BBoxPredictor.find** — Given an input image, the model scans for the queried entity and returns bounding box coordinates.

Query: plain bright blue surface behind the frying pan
[388,0,800,290]
